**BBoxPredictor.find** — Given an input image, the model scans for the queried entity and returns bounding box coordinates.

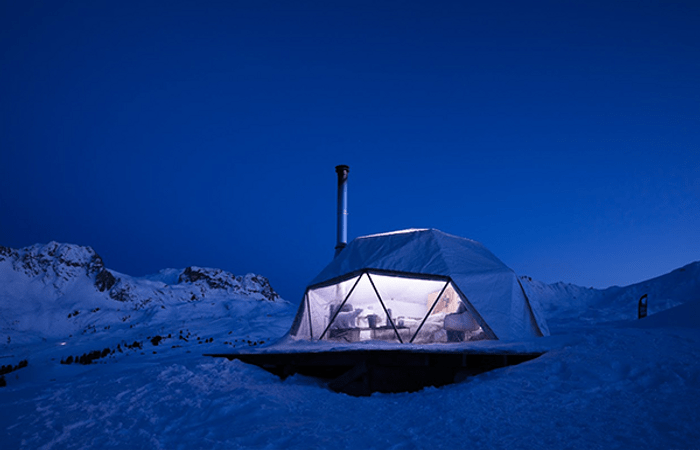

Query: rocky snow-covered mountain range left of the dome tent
[0,242,286,345]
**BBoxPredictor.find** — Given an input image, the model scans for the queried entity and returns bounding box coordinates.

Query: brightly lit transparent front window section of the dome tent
[293,272,489,344]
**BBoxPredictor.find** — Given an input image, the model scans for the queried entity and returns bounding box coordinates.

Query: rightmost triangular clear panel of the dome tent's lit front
[413,283,486,344]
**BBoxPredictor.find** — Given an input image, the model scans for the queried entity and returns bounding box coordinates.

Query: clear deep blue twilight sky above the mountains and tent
[0,0,700,301]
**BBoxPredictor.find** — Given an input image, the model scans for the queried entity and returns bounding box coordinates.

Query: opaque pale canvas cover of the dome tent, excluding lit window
[292,229,548,340]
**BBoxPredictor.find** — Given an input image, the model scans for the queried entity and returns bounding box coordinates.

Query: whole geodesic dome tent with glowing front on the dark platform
[289,229,549,344]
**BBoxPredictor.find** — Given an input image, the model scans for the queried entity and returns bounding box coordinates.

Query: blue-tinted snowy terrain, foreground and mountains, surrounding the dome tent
[0,243,700,449]
